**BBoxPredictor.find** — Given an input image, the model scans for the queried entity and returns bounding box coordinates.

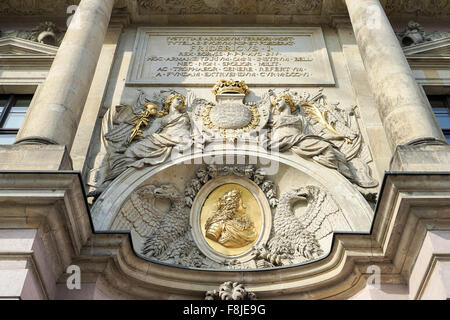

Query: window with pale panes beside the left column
[0,95,33,144]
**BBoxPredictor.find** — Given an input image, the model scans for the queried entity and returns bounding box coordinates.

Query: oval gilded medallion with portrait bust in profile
[200,184,262,255]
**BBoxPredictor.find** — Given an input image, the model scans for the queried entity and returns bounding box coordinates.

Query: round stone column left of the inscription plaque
[16,0,114,151]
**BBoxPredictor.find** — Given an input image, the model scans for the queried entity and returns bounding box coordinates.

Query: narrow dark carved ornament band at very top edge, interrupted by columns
[0,0,450,17]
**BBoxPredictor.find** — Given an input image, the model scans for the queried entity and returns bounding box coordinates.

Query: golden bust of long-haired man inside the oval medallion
[205,189,257,248]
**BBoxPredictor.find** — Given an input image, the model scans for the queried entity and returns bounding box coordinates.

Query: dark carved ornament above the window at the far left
[0,21,64,46]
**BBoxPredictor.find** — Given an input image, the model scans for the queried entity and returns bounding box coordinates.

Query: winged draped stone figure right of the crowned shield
[268,90,378,188]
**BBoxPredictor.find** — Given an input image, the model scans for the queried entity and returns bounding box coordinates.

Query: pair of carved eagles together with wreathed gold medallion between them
[110,162,351,269]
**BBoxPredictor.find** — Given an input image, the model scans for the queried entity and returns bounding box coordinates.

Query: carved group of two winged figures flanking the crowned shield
[89,80,378,201]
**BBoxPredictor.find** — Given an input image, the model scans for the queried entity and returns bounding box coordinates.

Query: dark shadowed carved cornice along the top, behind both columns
[0,0,450,25]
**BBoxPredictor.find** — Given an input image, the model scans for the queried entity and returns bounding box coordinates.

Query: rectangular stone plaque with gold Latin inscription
[127,27,335,86]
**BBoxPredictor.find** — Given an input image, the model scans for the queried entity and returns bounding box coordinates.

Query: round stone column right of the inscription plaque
[346,0,445,150]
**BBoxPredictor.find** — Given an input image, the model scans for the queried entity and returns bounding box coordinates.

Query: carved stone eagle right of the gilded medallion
[255,185,349,268]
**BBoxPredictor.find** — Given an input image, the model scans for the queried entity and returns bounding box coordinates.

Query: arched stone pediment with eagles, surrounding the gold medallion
[92,150,373,272]
